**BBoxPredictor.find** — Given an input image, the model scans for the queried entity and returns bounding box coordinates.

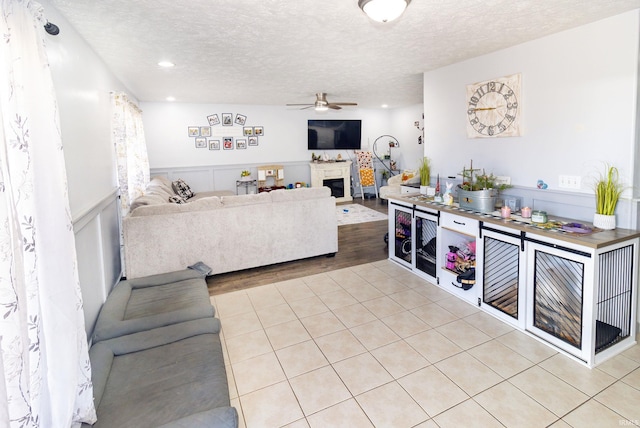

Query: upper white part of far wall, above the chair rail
[140,103,389,169]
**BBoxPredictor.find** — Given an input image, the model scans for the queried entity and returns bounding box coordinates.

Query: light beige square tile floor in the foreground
[211,260,640,428]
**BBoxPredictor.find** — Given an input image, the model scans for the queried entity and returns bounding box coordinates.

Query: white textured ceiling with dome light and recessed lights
[45,0,640,108]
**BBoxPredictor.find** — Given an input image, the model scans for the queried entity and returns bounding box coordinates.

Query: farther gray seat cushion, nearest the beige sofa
[93,269,214,343]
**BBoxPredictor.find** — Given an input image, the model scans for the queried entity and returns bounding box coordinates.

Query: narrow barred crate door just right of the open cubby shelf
[478,230,526,328]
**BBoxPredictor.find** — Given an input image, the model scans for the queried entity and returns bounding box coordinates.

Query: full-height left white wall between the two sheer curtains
[40,0,126,332]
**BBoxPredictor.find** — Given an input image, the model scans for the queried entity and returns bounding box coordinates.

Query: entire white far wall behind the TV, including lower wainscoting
[141,103,423,191]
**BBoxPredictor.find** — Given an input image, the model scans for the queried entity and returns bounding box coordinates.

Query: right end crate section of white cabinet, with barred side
[526,235,638,366]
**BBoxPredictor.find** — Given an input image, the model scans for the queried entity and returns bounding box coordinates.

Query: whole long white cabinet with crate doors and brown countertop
[389,196,640,367]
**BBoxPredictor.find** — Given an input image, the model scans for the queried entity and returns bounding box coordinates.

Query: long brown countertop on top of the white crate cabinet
[390,194,640,249]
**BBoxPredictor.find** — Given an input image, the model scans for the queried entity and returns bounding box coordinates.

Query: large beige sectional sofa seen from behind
[123,179,338,279]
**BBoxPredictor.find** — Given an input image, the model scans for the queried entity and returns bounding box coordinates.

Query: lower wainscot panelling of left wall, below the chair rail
[73,189,123,335]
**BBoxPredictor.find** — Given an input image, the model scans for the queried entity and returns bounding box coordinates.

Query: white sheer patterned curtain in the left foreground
[0,0,95,427]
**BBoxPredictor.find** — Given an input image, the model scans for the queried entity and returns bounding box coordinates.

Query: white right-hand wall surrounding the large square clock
[424,10,640,193]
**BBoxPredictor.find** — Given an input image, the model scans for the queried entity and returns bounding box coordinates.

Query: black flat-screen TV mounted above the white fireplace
[307,120,362,150]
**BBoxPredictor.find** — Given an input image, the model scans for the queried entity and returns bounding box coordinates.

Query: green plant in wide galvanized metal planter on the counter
[456,160,510,213]
